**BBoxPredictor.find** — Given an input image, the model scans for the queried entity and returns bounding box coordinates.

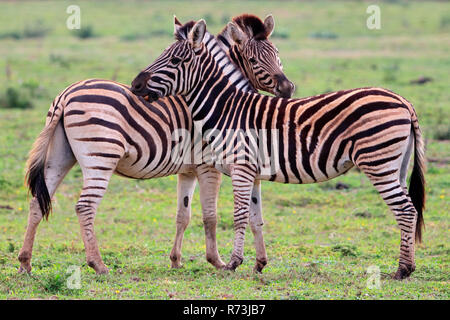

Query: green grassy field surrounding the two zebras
[0,1,450,299]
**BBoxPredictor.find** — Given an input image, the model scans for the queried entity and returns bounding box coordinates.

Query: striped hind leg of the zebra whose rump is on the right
[368,174,417,280]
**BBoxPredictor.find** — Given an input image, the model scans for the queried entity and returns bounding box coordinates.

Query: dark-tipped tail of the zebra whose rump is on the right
[408,117,426,242]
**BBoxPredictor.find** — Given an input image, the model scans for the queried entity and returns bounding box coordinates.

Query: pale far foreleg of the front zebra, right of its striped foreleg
[250,180,267,272]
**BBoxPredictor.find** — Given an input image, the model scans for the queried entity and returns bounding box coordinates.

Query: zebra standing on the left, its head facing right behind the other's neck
[19,15,293,274]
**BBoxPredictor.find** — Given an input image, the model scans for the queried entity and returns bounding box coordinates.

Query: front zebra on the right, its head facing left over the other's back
[132,20,425,279]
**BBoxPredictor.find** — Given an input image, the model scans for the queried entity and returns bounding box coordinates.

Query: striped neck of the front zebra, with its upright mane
[186,32,256,121]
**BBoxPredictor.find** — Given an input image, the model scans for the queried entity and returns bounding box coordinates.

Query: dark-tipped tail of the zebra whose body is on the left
[25,100,62,220]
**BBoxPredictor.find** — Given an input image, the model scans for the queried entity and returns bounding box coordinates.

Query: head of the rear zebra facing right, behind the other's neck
[225,14,295,98]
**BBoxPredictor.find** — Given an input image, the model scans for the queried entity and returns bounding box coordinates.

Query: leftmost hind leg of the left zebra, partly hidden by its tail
[18,120,76,273]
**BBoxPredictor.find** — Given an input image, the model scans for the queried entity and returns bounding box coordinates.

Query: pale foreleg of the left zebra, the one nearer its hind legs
[170,173,196,268]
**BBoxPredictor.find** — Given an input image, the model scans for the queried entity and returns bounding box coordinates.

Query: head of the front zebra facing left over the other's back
[131,17,206,102]
